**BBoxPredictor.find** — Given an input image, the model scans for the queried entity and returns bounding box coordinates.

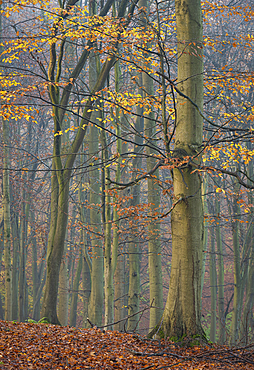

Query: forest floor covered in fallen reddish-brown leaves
[0,321,254,370]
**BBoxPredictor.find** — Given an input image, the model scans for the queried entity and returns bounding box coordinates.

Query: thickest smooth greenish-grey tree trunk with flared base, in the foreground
[162,0,204,338]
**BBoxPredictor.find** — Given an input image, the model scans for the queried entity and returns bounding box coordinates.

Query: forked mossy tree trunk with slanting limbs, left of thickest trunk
[41,0,139,323]
